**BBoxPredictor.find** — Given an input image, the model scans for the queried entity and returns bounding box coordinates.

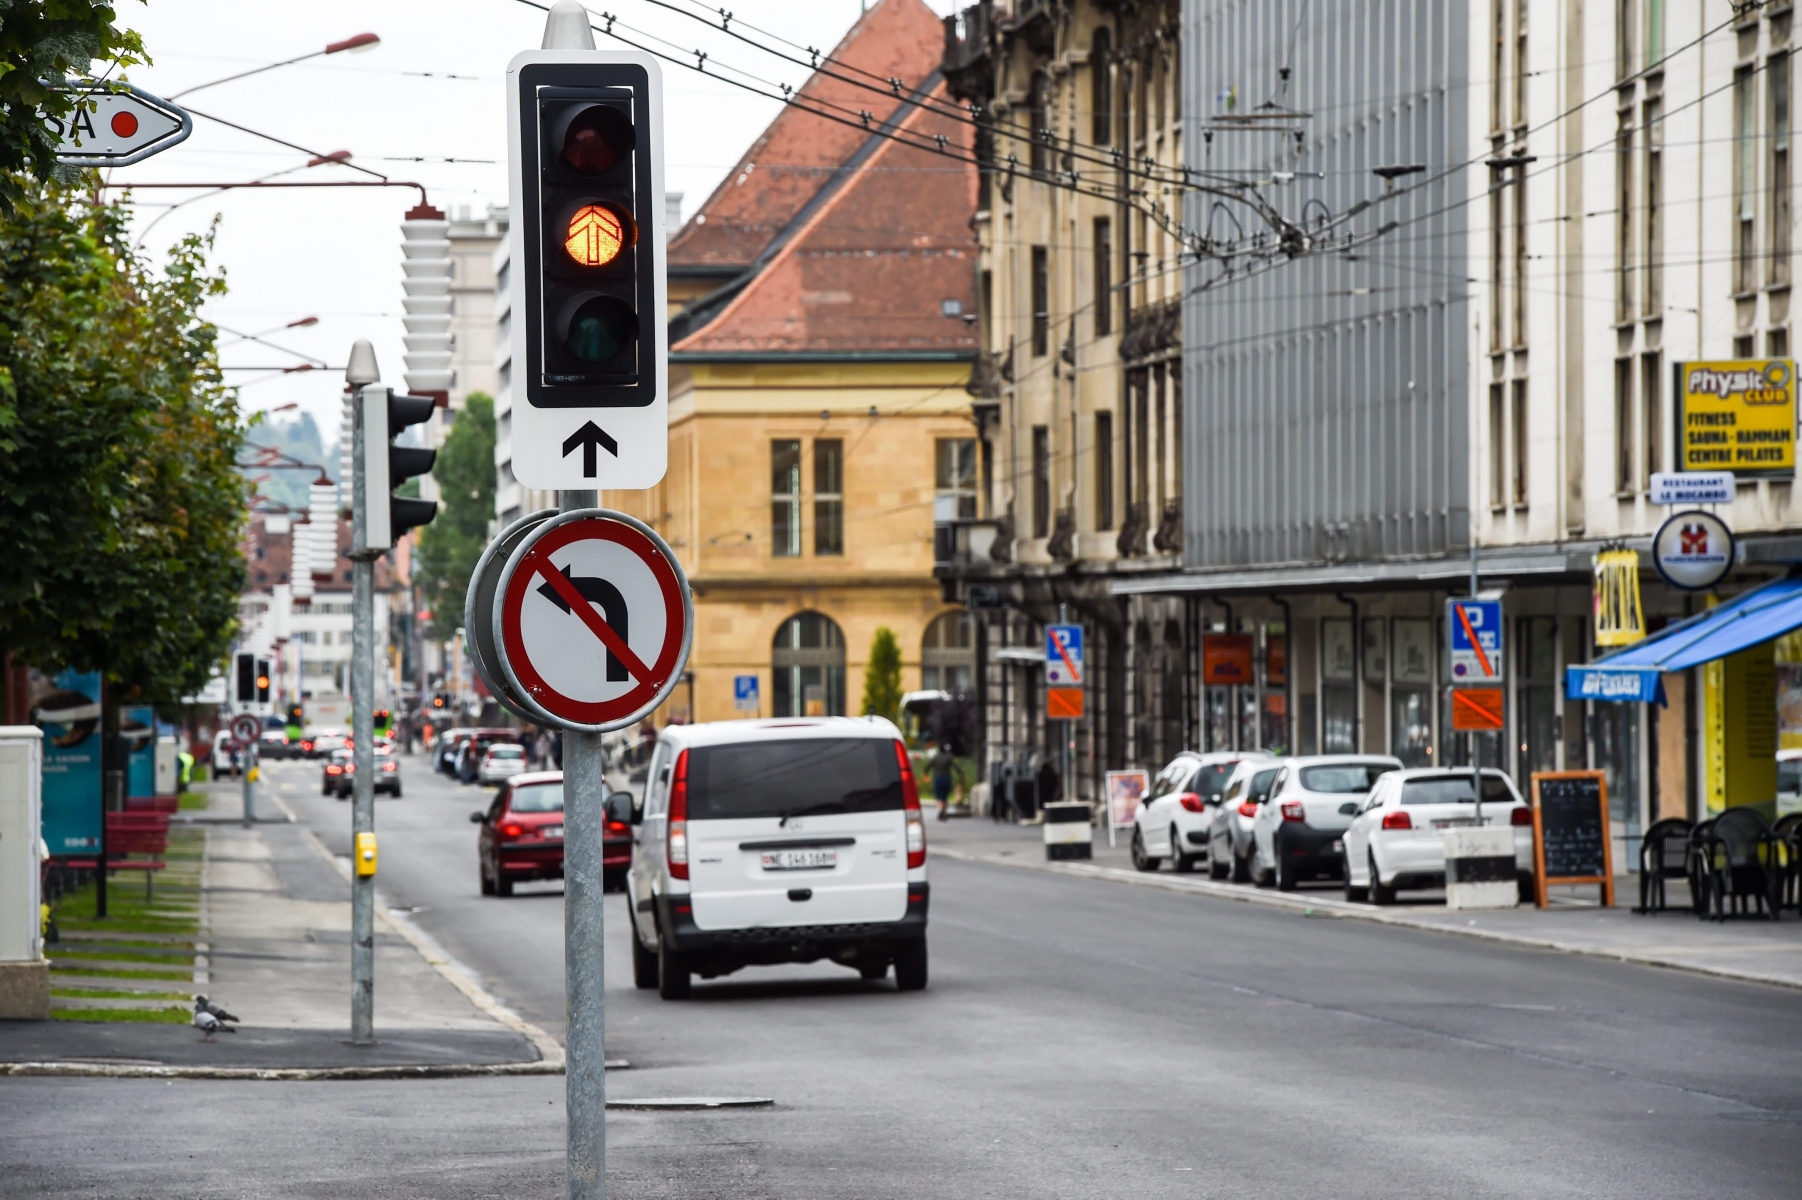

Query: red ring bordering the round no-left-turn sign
[499,517,688,724]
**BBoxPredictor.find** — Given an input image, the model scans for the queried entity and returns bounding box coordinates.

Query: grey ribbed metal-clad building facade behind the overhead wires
[1182,0,1472,569]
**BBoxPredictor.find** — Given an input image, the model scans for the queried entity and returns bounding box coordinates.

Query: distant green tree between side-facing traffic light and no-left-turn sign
[414,391,494,641]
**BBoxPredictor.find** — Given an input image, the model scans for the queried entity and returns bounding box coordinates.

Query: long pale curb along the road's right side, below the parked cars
[932,847,1802,991]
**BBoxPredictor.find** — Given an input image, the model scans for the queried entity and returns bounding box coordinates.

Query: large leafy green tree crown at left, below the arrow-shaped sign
[0,172,245,708]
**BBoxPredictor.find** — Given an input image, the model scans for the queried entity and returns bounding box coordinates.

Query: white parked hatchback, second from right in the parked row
[1251,755,1402,892]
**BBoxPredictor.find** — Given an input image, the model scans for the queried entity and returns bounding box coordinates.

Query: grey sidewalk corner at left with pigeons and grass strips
[0,782,562,1079]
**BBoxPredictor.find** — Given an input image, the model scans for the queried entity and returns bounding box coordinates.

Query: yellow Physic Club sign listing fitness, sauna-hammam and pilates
[1676,359,1797,479]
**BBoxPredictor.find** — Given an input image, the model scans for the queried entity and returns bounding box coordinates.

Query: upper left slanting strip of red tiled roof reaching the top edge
[669,0,944,274]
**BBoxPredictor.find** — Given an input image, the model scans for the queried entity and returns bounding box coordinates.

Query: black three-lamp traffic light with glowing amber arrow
[514,54,663,407]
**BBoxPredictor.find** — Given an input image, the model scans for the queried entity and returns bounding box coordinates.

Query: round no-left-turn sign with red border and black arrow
[494,508,694,732]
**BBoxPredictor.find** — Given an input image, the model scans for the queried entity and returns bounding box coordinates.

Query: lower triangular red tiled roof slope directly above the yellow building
[672,0,977,355]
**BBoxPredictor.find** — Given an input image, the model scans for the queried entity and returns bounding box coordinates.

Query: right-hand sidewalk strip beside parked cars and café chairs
[926,818,1802,987]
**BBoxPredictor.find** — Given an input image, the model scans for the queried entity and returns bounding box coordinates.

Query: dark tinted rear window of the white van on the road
[688,737,901,820]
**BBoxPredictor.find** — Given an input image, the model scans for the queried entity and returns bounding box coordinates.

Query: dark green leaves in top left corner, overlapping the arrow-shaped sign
[0,0,150,214]
